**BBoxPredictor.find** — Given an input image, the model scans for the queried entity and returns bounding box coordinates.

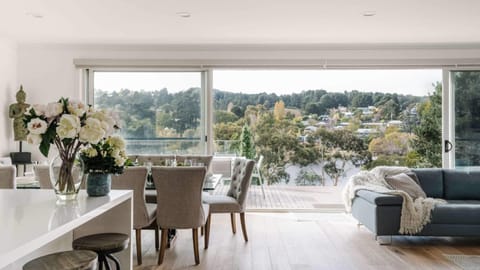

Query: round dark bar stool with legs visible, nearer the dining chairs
[72,233,129,270]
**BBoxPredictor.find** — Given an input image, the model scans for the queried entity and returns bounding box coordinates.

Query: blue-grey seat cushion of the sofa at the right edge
[431,200,480,225]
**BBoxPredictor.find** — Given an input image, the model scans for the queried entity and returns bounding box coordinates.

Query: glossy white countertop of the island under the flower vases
[0,189,133,269]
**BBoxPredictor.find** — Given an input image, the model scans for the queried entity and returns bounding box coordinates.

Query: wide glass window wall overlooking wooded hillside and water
[89,68,444,208]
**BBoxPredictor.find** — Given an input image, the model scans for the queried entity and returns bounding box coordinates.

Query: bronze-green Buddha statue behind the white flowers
[8,85,30,141]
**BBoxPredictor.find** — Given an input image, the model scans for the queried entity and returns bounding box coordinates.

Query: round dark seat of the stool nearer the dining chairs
[72,233,129,253]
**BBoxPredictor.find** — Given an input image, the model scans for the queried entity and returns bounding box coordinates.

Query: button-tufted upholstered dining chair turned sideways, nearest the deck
[203,158,255,248]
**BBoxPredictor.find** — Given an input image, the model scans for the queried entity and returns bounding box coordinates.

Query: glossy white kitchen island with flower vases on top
[0,189,133,270]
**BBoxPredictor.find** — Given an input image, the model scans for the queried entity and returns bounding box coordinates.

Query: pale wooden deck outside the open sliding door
[213,183,343,211]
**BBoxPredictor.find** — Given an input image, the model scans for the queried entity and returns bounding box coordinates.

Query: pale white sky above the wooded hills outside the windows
[95,69,442,96]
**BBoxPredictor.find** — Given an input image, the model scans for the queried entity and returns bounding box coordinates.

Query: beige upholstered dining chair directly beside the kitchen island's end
[112,166,159,265]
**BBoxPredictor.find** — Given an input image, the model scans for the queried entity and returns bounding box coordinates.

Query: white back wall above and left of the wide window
[16,44,480,160]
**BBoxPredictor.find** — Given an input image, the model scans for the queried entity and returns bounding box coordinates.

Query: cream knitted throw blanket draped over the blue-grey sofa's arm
[342,166,445,235]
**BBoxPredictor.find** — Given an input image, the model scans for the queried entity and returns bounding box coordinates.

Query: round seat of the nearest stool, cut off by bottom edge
[23,250,97,270]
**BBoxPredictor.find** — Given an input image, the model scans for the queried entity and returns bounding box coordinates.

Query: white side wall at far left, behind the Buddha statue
[0,38,19,157]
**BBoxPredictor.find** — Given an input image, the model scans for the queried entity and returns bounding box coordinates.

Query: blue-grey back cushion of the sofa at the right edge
[443,170,480,200]
